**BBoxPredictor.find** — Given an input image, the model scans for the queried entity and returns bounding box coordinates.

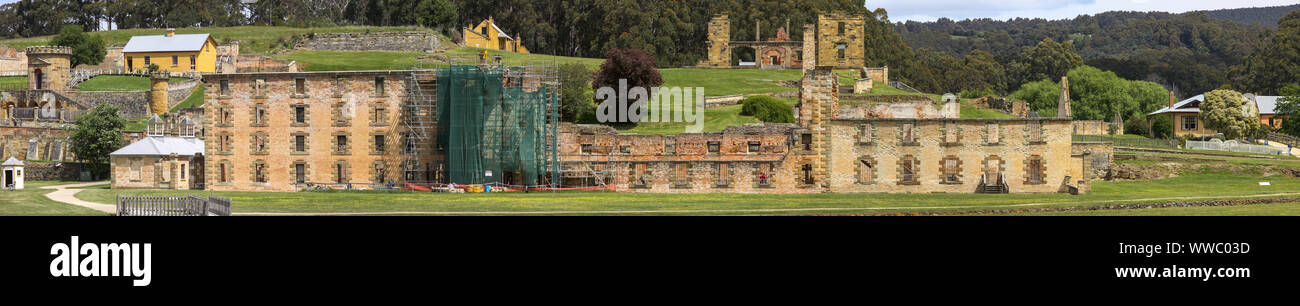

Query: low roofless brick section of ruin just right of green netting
[559,124,820,193]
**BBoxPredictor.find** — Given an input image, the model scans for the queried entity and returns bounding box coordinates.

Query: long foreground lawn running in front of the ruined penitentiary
[68,172,1300,215]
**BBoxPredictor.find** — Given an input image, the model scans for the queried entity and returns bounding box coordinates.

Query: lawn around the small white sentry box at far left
[0,181,108,216]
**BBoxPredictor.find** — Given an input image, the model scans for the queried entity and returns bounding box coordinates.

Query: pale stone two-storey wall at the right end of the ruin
[827,118,1084,193]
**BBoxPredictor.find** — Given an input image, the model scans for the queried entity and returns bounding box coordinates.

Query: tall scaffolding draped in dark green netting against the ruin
[434,56,559,188]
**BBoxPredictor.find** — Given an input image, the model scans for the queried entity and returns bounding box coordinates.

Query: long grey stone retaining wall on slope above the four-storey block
[298,31,442,52]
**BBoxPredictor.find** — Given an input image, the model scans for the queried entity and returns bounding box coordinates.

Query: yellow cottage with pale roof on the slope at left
[122,29,217,73]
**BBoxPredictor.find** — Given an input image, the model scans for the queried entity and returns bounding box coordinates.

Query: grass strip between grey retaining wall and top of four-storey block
[276,51,424,72]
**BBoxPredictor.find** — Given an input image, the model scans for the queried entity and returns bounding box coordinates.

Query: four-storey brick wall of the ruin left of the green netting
[203,72,416,191]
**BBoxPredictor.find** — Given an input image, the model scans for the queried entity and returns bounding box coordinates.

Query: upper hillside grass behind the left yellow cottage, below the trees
[0,26,431,55]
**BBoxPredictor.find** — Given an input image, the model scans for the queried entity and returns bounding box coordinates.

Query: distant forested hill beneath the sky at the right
[896,12,1265,95]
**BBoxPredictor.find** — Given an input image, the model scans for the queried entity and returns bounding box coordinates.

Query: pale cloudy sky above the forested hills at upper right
[867,0,1300,22]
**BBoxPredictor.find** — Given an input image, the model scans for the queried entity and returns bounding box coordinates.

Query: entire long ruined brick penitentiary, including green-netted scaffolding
[202,55,1109,194]
